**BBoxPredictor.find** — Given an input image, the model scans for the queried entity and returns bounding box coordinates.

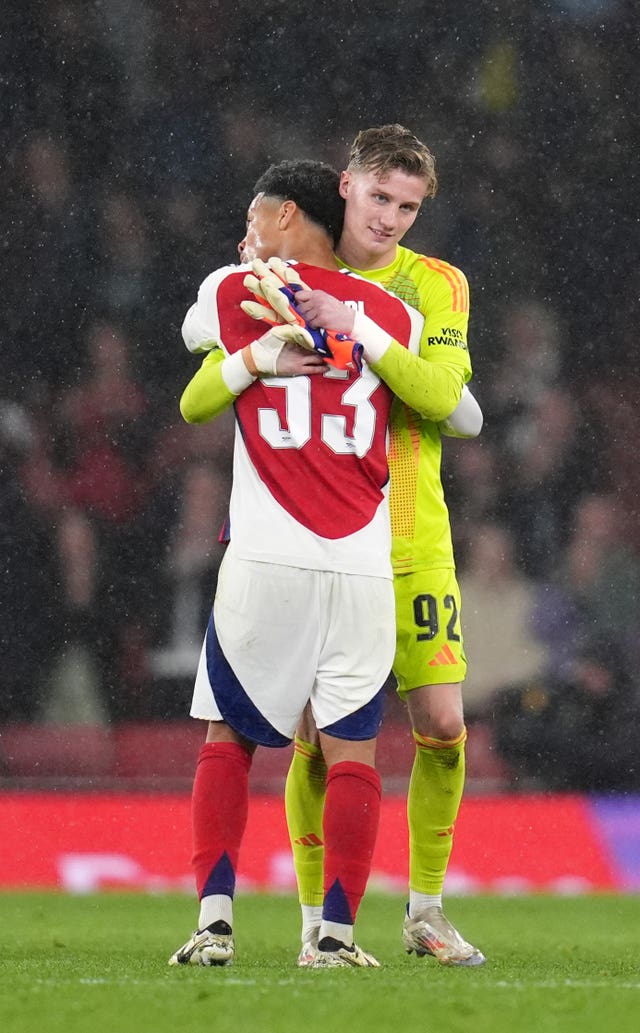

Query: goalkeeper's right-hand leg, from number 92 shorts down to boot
[394,570,484,966]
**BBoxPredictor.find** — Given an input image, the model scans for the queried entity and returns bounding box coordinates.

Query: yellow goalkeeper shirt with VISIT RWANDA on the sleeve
[341,247,472,574]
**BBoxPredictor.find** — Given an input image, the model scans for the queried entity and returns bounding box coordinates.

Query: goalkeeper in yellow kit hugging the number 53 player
[248,125,484,967]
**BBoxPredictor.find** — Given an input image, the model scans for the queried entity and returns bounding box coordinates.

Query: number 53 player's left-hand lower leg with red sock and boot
[169,721,255,966]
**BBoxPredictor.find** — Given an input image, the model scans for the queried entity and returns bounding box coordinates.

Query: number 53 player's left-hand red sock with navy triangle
[191,743,252,900]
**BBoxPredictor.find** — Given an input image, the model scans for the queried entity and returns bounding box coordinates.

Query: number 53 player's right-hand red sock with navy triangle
[323,760,381,926]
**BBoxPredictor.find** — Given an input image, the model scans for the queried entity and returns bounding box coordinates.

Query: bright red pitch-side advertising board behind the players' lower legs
[0,792,640,894]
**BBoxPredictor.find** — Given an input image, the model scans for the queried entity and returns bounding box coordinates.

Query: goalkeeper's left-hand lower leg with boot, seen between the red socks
[285,707,326,967]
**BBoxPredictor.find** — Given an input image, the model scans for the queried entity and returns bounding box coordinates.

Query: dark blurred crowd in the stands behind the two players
[0,0,640,789]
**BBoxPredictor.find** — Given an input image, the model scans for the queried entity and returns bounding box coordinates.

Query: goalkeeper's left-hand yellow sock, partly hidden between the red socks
[285,735,326,905]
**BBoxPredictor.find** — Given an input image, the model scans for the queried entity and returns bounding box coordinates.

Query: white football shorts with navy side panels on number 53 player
[191,544,395,746]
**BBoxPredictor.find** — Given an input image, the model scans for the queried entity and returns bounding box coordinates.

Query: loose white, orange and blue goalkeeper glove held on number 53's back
[241,258,362,372]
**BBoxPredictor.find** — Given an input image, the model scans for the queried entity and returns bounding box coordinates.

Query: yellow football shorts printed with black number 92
[393,567,467,696]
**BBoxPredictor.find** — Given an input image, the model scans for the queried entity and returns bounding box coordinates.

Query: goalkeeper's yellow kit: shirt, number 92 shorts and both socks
[285,247,471,906]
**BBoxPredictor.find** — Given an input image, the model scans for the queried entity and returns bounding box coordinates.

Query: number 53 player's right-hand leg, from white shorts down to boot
[311,574,395,967]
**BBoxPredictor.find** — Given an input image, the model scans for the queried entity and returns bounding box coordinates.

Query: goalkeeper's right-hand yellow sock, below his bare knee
[407,729,467,895]
